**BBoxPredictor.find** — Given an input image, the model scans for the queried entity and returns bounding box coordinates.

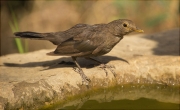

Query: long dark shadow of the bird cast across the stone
[4,56,129,70]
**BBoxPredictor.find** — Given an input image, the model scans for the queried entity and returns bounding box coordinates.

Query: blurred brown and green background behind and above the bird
[0,0,180,55]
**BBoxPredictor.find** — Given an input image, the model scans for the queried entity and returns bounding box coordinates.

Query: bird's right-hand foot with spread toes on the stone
[99,64,116,77]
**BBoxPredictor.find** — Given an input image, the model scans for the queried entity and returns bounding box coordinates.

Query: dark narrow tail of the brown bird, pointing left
[14,31,48,40]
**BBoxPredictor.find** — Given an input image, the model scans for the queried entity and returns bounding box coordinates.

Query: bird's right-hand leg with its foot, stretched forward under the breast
[86,57,116,77]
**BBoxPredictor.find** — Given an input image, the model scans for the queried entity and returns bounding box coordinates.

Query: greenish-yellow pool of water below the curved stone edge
[42,84,180,110]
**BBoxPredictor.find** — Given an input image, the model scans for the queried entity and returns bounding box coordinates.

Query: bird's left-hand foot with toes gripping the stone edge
[73,68,91,85]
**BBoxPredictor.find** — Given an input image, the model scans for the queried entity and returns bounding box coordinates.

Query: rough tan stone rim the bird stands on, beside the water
[0,29,180,109]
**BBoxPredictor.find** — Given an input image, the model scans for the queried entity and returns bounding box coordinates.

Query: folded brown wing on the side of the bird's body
[55,24,104,55]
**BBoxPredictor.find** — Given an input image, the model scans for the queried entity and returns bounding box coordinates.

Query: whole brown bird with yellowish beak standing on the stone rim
[14,19,143,84]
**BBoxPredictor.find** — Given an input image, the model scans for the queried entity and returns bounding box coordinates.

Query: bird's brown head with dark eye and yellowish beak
[107,19,144,36]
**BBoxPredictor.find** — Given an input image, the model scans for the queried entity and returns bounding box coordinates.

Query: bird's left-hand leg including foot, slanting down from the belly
[72,57,91,84]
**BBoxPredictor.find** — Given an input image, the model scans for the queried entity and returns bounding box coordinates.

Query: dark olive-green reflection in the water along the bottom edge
[63,98,179,110]
